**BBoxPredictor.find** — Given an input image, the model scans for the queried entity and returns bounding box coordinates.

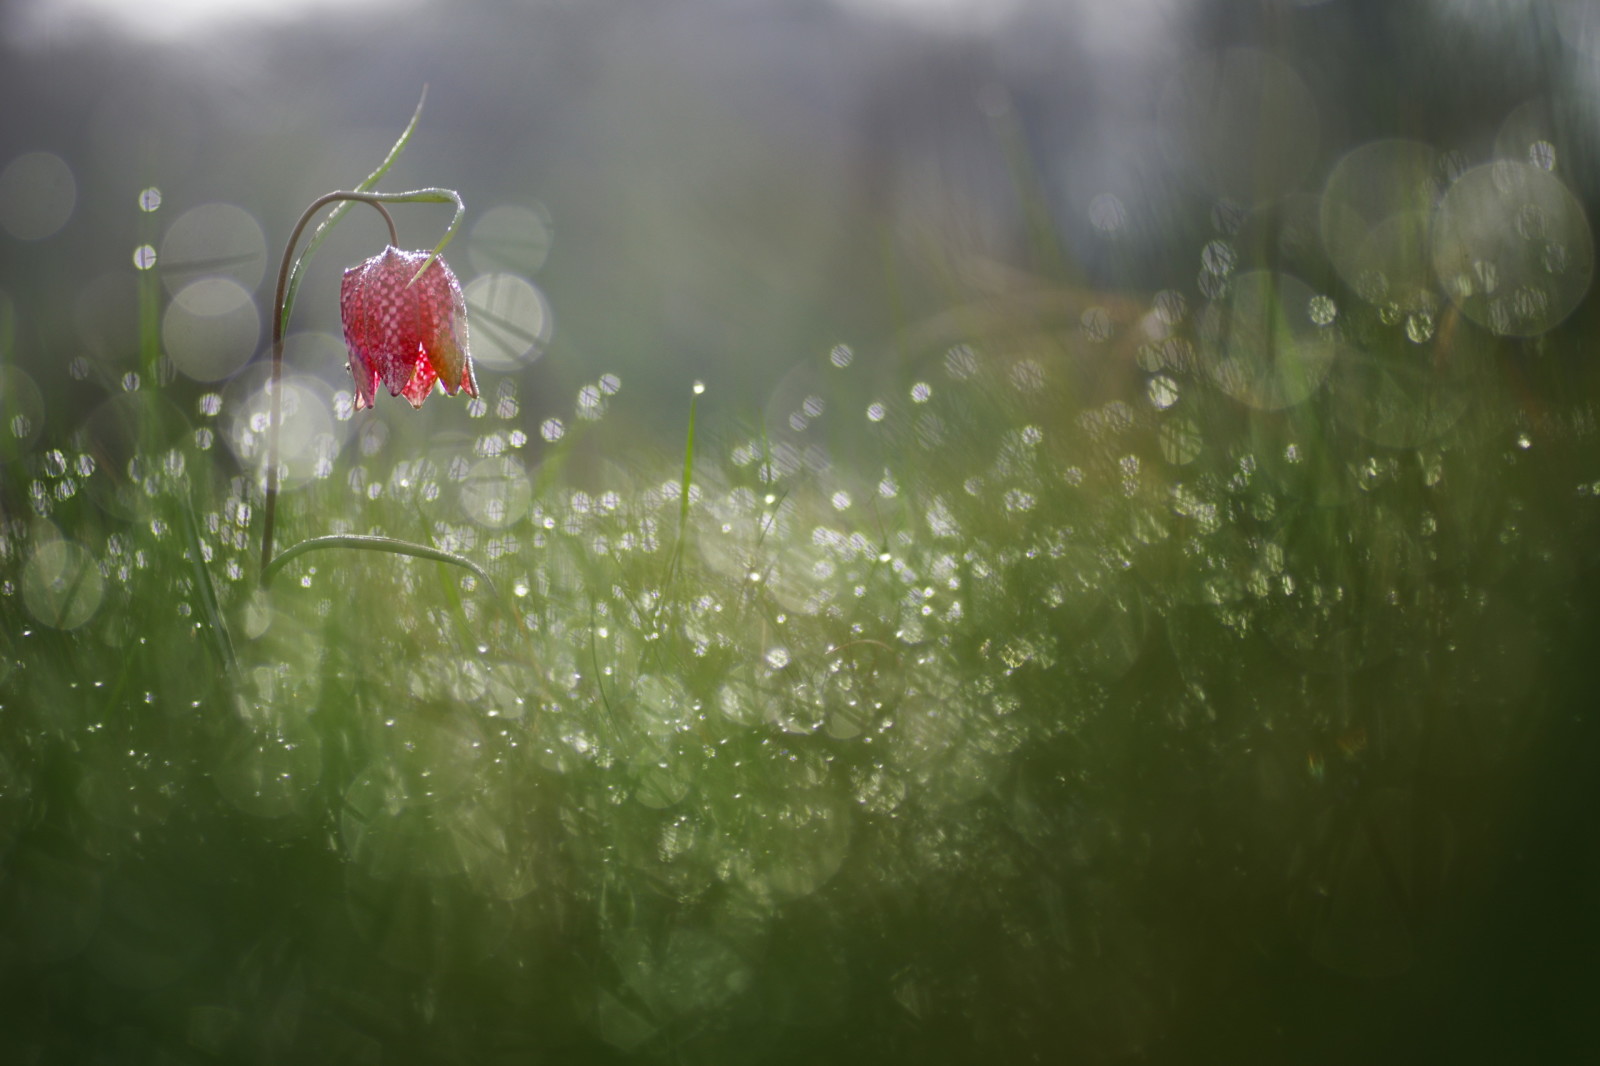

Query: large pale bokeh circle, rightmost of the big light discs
[1434,160,1594,336]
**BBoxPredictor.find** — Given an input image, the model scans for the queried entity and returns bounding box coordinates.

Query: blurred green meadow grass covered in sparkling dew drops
[0,4,1600,1063]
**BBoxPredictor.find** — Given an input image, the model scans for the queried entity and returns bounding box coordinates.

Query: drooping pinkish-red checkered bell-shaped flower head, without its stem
[339,246,478,410]
